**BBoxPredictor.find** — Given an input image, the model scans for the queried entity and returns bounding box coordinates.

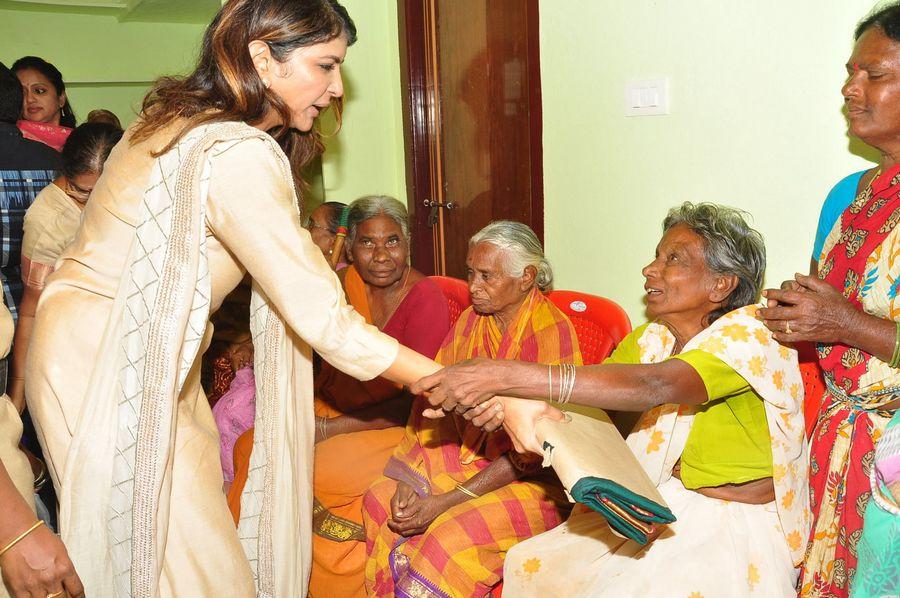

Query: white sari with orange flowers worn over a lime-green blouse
[503,305,809,598]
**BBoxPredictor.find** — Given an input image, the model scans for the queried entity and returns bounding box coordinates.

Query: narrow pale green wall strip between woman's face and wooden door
[322,0,406,207]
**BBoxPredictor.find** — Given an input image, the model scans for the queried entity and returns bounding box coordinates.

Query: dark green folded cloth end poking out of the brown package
[569,477,675,545]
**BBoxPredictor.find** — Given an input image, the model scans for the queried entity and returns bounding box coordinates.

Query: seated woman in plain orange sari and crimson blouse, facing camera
[309,196,450,598]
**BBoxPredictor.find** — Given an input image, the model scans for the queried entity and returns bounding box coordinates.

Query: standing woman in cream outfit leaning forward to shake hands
[25,0,436,597]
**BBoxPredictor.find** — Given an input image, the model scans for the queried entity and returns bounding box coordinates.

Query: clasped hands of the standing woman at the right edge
[759,274,860,343]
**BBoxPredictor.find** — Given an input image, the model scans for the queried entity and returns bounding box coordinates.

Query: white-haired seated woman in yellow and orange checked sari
[363,221,581,596]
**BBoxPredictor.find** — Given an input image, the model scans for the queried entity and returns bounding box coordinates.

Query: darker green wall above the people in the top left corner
[0,3,205,124]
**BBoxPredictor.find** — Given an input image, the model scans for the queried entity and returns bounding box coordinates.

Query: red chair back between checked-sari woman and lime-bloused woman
[548,291,631,365]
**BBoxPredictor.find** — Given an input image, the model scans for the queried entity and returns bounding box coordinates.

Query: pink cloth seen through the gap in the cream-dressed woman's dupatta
[213,366,256,483]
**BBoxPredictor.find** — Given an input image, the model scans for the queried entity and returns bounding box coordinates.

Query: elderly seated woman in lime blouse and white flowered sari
[412,203,808,596]
